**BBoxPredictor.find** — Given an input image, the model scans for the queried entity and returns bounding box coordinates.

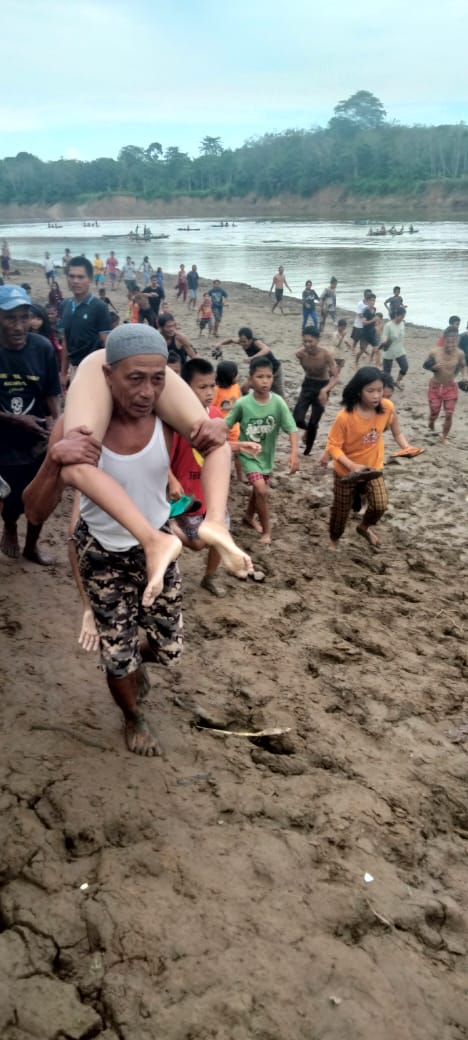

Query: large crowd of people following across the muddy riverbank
[0,243,468,755]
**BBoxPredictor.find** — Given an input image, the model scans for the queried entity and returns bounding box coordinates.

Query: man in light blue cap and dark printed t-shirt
[0,285,60,565]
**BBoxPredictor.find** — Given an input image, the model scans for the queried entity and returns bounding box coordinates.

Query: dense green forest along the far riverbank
[0,90,468,212]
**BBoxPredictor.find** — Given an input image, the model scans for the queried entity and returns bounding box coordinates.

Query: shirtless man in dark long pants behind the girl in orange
[292,326,340,456]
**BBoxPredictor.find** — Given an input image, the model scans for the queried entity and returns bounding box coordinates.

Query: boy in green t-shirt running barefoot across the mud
[226,356,298,545]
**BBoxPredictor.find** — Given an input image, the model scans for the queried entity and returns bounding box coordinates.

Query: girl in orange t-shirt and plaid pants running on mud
[327,365,416,549]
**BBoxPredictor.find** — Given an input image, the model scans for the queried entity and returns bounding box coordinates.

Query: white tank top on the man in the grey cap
[80,419,170,552]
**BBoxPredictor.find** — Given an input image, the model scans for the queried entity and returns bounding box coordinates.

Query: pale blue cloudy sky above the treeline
[0,0,468,159]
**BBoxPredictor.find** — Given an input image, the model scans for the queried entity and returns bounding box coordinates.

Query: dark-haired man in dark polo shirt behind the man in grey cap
[60,257,112,386]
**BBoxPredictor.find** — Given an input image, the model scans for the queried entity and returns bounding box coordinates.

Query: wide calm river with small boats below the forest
[0,217,468,329]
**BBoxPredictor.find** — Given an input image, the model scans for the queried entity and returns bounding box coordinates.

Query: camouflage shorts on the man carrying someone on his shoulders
[74,520,183,678]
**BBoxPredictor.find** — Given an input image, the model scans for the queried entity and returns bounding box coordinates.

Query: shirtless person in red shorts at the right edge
[422,326,465,444]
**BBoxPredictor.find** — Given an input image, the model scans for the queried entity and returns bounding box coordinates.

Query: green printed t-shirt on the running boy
[226,393,297,475]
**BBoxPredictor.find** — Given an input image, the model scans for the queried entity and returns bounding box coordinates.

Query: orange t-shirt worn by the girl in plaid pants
[327,397,395,476]
